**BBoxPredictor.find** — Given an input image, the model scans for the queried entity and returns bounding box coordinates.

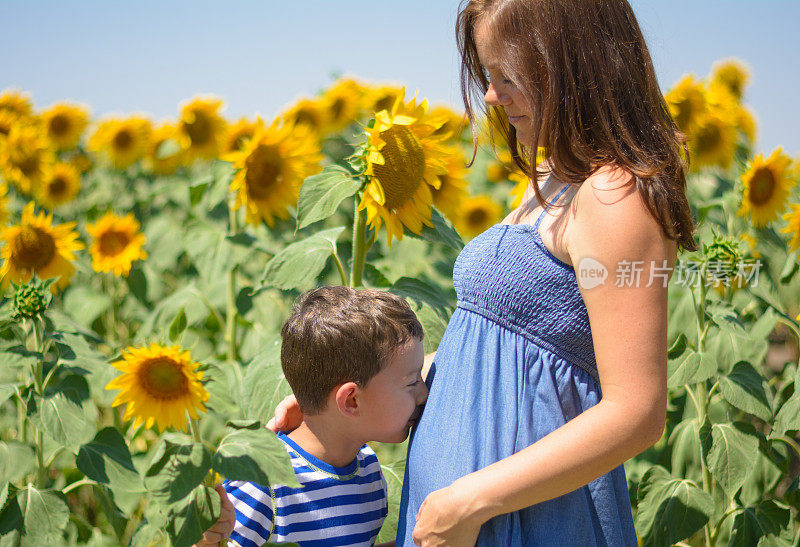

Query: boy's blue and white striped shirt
[223,433,388,547]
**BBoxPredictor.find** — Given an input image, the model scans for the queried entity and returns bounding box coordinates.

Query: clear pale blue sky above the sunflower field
[0,0,800,156]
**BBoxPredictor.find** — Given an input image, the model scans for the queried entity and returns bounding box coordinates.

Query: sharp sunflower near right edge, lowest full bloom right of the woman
[738,147,795,227]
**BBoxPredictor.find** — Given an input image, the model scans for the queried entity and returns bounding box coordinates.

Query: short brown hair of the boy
[281,286,423,414]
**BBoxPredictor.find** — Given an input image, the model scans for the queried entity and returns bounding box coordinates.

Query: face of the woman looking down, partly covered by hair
[475,21,533,146]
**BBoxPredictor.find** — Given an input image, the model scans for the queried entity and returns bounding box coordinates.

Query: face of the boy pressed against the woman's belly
[361,337,428,443]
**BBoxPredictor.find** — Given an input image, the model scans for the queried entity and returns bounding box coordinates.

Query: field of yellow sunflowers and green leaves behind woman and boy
[0,60,800,546]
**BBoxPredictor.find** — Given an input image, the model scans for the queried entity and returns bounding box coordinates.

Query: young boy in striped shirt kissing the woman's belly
[199,287,428,547]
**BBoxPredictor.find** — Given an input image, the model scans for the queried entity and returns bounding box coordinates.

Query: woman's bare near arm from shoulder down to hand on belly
[413,170,674,544]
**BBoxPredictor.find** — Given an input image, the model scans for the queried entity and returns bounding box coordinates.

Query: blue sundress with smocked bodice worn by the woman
[397,185,637,547]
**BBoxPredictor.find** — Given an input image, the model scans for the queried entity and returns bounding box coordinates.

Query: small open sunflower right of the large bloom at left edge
[86,213,147,277]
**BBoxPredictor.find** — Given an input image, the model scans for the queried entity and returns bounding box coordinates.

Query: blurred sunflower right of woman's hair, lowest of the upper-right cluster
[689,109,737,171]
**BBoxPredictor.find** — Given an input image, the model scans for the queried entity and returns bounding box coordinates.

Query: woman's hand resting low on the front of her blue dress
[411,479,483,547]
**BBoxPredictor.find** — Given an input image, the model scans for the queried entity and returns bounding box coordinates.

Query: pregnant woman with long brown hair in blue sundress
[268,0,696,547]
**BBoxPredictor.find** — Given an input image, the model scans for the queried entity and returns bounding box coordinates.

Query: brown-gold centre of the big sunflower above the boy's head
[373,125,425,209]
